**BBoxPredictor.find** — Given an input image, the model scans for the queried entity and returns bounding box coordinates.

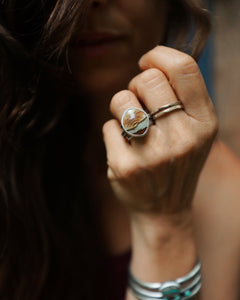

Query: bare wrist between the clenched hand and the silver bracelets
[126,212,197,300]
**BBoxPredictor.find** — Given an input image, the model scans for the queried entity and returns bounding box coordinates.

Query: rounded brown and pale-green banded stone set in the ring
[121,107,149,137]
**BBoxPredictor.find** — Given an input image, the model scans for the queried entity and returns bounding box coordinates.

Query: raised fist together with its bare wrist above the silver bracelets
[103,46,217,300]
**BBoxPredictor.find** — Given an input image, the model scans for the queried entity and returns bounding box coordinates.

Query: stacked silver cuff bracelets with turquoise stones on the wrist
[129,260,201,300]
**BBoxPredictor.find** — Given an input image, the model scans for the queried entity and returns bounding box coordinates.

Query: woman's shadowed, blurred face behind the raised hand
[70,0,167,97]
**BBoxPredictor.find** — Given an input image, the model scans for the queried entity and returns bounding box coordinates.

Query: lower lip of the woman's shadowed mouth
[71,38,122,58]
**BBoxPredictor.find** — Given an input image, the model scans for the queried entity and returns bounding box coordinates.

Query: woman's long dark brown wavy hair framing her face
[0,0,210,300]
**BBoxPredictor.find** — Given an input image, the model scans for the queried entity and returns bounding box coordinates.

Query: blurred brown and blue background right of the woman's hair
[200,0,240,157]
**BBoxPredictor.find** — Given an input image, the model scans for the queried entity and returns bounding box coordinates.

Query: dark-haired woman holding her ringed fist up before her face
[0,0,237,300]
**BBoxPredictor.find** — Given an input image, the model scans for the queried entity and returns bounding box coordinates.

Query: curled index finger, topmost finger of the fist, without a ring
[139,46,213,119]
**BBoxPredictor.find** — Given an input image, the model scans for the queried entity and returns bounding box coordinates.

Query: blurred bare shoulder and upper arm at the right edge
[193,140,240,300]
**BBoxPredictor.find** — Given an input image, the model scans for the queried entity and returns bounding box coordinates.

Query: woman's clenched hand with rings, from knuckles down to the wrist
[103,46,217,215]
